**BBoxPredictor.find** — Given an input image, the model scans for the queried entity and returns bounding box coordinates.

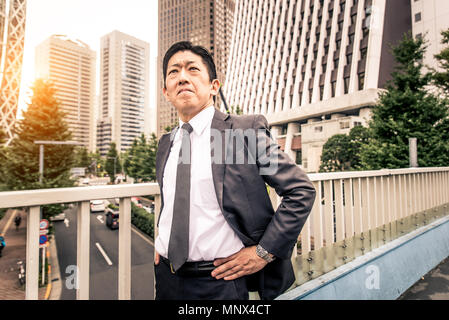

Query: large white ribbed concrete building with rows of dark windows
[224,0,412,172]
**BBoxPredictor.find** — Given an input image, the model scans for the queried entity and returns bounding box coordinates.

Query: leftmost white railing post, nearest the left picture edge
[25,206,40,300]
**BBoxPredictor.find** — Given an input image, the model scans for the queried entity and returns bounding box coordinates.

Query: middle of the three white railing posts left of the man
[76,201,90,300]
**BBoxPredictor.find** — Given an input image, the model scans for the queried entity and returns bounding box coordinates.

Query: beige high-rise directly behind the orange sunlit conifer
[35,35,96,151]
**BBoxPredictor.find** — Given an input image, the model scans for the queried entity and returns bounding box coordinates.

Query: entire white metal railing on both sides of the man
[0,167,449,299]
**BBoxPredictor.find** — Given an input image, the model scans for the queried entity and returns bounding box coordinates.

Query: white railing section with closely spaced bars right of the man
[277,167,449,285]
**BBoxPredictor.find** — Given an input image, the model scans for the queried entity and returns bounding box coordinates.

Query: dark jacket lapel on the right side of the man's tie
[211,109,232,212]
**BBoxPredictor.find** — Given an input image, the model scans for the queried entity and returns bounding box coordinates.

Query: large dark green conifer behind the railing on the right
[361,34,449,170]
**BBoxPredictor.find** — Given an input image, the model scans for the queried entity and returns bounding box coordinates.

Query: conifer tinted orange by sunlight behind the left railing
[4,79,74,190]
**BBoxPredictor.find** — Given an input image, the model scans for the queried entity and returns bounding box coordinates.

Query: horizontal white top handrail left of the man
[0,182,160,209]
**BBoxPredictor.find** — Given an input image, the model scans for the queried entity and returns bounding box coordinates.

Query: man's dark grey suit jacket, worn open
[156,110,315,299]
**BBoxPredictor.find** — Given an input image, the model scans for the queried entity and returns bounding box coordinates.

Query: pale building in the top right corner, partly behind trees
[410,0,449,72]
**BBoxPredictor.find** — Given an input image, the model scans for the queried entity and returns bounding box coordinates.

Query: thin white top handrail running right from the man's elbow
[307,167,449,181]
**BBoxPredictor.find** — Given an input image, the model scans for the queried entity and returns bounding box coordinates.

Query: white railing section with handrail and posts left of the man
[0,183,160,300]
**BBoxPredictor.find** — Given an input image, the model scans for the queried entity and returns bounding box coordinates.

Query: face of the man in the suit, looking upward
[162,51,220,121]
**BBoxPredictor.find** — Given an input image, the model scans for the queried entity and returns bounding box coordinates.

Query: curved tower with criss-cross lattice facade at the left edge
[0,0,27,144]
